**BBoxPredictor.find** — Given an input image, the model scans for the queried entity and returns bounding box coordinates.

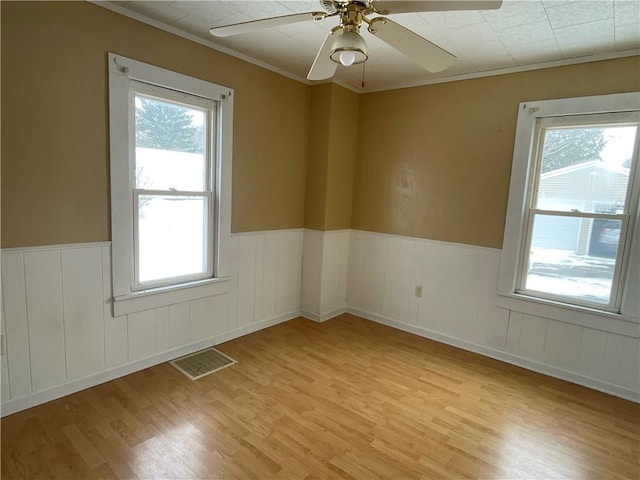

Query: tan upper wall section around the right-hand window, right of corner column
[352,57,640,248]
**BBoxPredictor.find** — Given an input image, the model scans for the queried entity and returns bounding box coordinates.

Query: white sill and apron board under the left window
[113,277,231,317]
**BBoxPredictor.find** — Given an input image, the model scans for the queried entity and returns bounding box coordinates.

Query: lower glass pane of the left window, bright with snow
[137,195,208,283]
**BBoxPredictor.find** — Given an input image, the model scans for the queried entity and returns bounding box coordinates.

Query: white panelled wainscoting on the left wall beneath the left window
[0,229,303,416]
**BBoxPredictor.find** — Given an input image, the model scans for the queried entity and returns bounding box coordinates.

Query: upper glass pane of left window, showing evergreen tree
[135,95,207,191]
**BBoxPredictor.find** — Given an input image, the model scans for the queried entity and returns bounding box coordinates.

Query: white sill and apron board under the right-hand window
[496,293,640,338]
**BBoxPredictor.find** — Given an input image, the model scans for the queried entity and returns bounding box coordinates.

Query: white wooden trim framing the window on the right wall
[496,92,640,337]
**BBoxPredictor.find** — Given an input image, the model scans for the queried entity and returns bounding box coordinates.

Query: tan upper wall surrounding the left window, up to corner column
[1,2,309,247]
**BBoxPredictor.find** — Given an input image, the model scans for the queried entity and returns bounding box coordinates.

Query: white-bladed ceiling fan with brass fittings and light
[209,0,502,80]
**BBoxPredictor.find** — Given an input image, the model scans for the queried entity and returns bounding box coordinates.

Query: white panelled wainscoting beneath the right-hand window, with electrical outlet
[347,230,640,401]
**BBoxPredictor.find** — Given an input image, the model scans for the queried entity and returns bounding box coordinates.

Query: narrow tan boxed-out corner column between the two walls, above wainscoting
[304,84,358,230]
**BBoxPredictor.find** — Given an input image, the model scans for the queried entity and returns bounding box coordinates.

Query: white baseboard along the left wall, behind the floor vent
[0,310,300,417]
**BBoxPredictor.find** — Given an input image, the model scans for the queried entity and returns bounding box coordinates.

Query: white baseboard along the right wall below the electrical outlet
[346,307,640,403]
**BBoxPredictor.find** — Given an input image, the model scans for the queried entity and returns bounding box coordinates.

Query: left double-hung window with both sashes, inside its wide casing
[130,82,216,290]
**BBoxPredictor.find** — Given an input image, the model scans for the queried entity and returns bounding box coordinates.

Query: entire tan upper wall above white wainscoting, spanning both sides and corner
[1,2,640,247]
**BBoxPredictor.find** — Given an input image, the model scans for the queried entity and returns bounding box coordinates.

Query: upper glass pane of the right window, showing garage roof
[535,126,636,213]
